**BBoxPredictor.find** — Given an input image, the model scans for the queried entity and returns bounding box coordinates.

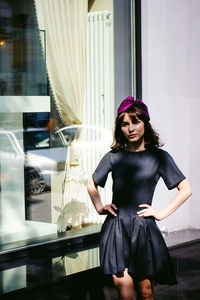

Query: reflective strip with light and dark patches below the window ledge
[0,248,99,295]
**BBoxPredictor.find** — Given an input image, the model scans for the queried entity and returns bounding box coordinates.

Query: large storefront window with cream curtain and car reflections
[0,0,132,249]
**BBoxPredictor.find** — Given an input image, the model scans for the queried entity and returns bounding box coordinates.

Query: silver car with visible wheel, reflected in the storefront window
[0,129,66,194]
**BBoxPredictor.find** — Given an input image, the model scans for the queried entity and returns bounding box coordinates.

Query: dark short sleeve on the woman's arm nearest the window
[92,152,111,187]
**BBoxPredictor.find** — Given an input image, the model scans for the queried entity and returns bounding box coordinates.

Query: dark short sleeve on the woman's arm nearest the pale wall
[158,149,185,190]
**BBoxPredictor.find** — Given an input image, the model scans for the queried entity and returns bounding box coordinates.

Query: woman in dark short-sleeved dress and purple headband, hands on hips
[88,97,191,299]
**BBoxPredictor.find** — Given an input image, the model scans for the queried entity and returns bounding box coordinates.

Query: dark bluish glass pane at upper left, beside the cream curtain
[0,27,47,95]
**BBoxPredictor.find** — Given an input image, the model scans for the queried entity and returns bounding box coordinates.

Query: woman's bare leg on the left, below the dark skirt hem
[113,269,136,300]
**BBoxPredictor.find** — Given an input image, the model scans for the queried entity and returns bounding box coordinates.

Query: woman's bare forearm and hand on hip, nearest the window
[87,178,117,217]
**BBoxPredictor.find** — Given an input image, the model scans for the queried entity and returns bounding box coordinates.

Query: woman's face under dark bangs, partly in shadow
[121,113,144,143]
